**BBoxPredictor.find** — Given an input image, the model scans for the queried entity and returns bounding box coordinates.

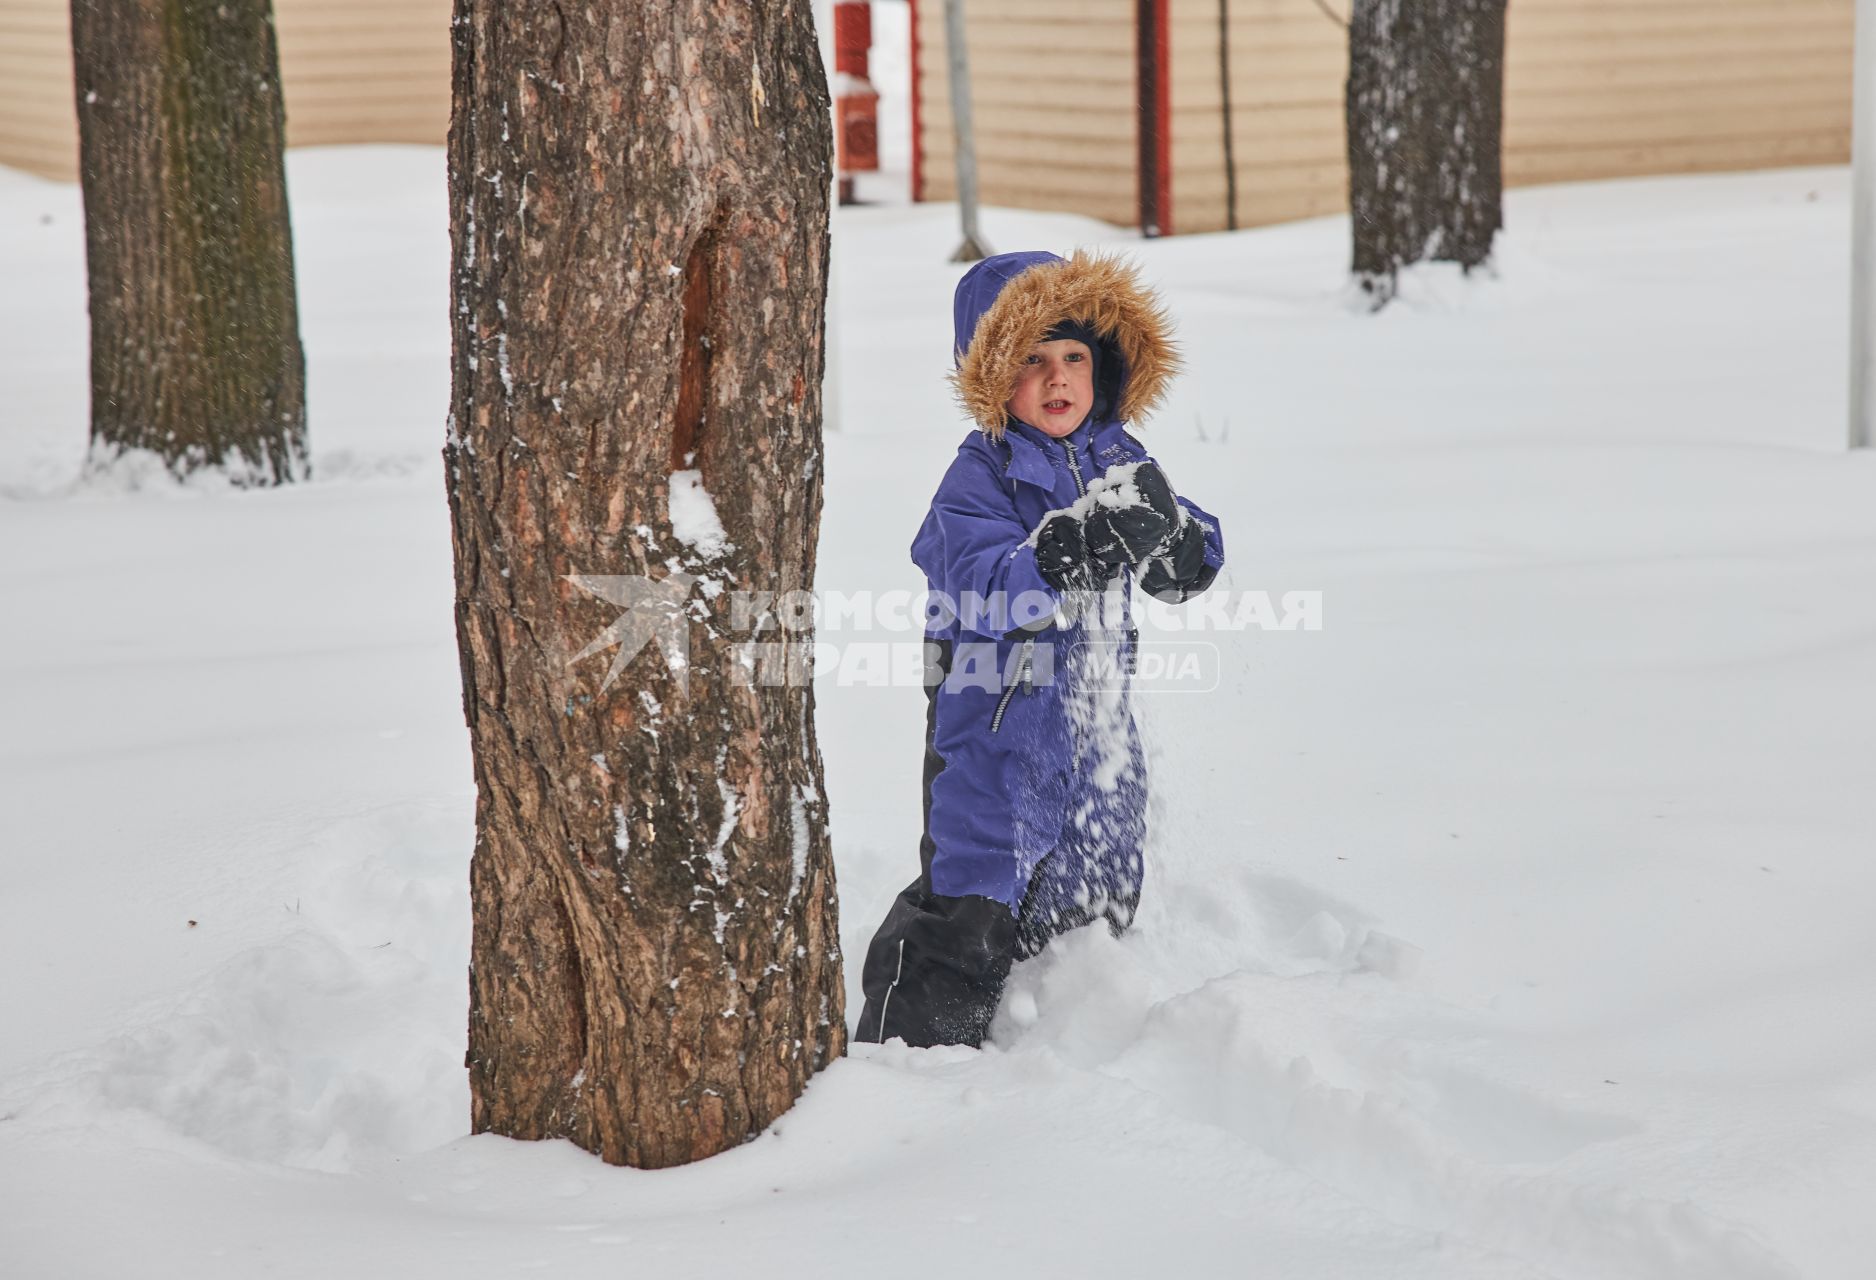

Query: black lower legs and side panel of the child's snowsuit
[854,640,1139,1047]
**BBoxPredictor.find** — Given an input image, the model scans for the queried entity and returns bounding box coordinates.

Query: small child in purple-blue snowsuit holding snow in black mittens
[855,253,1225,1045]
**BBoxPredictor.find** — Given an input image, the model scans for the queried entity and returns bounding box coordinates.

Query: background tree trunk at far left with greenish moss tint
[71,0,308,484]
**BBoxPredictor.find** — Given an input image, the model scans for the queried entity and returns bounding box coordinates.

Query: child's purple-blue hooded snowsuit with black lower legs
[857,253,1223,1044]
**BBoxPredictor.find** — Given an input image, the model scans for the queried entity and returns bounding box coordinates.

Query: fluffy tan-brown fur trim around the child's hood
[951,250,1180,437]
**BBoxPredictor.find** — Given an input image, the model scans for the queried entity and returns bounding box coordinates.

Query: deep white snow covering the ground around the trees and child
[0,148,1876,1280]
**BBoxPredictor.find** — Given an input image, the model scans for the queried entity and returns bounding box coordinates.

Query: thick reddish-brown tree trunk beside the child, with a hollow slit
[445,0,846,1167]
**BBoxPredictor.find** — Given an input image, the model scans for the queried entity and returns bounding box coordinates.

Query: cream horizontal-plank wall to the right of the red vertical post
[1173,0,1853,231]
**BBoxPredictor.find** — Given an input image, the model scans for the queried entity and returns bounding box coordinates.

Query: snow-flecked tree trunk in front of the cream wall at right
[1347,0,1505,310]
